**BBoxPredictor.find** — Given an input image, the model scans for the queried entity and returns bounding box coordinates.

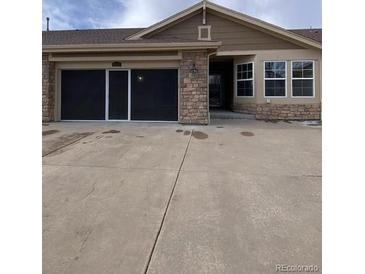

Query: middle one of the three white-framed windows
[264,61,286,97]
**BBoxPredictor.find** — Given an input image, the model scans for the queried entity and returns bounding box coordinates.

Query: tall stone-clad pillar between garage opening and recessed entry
[179,51,209,125]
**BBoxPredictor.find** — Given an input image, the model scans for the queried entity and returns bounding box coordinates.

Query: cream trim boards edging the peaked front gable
[126,1,322,49]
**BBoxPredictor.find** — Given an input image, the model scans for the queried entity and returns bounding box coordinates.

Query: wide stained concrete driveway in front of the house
[43,120,321,274]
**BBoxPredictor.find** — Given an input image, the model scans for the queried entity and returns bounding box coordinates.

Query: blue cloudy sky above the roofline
[42,0,322,30]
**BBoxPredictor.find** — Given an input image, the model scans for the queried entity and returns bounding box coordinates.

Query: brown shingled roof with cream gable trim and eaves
[42,1,322,51]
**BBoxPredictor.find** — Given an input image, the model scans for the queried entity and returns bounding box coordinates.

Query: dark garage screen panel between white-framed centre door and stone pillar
[131,69,178,121]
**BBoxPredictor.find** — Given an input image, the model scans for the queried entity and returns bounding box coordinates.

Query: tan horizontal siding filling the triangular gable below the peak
[149,9,301,51]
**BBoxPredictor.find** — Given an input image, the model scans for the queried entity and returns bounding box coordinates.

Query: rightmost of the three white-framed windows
[292,61,314,97]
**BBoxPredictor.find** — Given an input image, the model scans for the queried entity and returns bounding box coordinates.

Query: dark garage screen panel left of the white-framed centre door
[61,70,105,120]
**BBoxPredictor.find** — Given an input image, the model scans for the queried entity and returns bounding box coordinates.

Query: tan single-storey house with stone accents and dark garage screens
[42,1,322,124]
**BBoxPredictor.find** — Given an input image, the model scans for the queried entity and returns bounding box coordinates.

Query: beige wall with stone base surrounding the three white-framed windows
[233,49,322,119]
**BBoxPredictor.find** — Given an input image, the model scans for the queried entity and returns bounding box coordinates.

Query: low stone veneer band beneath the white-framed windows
[233,103,321,120]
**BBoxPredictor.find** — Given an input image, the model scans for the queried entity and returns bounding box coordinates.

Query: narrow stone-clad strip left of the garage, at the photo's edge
[42,54,56,122]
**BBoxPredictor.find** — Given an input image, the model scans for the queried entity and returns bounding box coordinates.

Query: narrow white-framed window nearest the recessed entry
[237,63,254,97]
